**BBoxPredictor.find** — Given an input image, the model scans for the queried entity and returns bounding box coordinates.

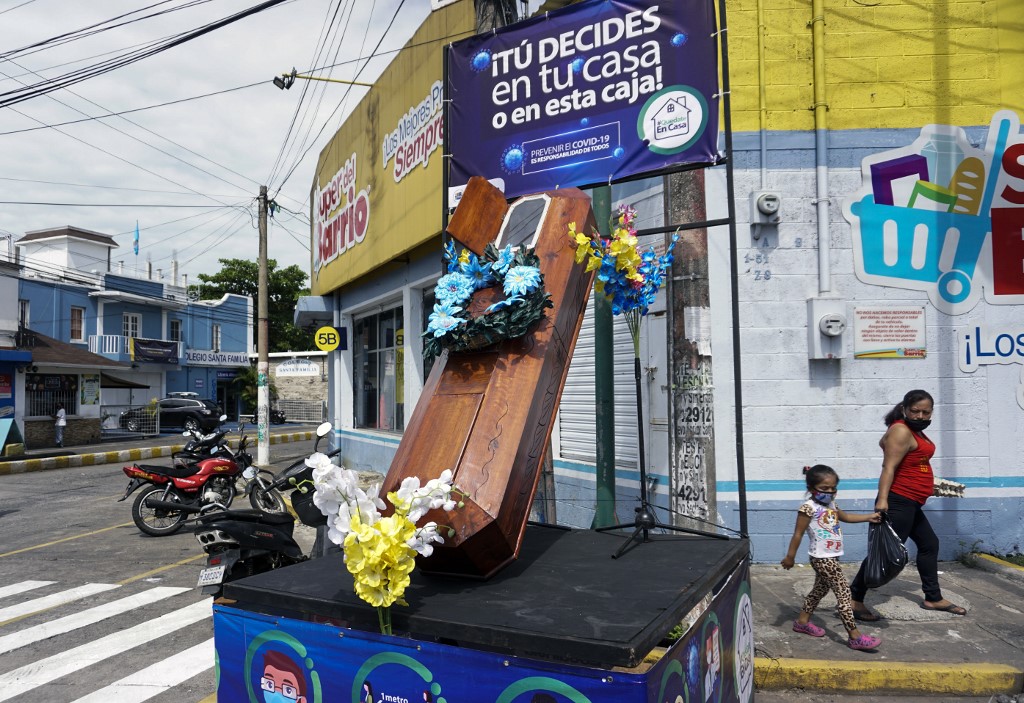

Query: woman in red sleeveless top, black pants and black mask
[850,390,967,622]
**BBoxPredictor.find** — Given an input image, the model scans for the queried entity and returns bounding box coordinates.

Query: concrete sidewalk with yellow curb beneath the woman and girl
[751,555,1024,697]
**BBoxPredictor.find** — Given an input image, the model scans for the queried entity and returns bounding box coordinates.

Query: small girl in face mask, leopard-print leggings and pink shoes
[781,464,882,650]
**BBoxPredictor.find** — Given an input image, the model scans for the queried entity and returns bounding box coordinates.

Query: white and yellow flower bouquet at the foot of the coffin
[306,453,463,634]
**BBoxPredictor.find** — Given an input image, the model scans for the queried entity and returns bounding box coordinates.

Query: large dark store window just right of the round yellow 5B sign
[352,307,406,432]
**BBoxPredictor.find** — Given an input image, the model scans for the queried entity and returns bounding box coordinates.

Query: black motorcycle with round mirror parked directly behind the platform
[196,423,341,598]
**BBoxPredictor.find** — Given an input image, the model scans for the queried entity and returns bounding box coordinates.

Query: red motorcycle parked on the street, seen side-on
[118,425,287,537]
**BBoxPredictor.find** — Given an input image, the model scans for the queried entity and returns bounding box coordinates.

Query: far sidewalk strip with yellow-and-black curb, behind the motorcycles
[0,425,315,476]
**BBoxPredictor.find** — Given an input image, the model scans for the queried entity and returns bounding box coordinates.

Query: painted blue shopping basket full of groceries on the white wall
[843,111,1024,315]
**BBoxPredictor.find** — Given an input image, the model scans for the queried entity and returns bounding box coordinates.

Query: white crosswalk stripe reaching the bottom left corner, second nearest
[0,599,213,701]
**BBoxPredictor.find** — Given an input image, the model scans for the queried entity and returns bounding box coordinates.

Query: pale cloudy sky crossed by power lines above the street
[0,0,539,283]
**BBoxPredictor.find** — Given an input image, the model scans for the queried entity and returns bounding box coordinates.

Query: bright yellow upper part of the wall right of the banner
[726,0,1024,131]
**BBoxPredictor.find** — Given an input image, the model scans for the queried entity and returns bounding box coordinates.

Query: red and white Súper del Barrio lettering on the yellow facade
[313,153,370,276]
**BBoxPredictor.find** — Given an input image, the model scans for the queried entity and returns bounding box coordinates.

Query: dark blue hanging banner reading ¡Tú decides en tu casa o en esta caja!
[444,0,720,200]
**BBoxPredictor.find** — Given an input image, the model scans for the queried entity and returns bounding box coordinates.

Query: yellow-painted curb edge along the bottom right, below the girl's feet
[754,657,1024,697]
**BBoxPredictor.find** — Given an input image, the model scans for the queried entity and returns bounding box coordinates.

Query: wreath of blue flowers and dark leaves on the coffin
[423,241,552,359]
